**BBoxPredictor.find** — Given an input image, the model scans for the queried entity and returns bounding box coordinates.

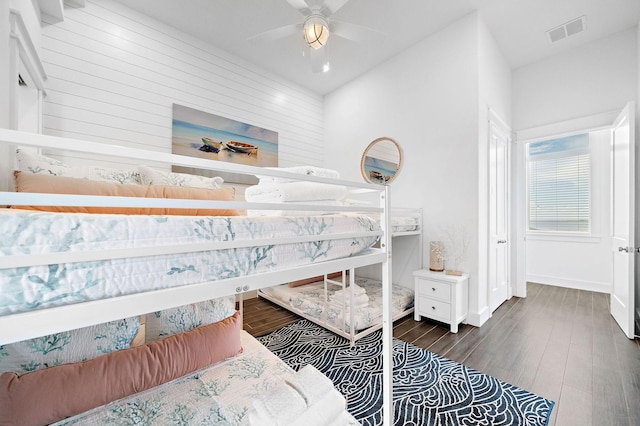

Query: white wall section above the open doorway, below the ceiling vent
[512,28,638,131]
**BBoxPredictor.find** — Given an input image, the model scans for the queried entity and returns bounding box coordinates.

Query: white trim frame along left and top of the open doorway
[512,110,620,297]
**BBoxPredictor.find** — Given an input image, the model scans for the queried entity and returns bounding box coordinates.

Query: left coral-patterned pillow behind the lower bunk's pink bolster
[0,317,140,374]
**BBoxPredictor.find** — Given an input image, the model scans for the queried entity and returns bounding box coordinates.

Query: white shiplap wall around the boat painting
[42,0,323,171]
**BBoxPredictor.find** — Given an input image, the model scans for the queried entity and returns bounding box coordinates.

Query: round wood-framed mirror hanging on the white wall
[360,138,402,185]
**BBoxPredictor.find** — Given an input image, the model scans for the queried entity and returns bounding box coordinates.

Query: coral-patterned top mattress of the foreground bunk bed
[0,209,379,315]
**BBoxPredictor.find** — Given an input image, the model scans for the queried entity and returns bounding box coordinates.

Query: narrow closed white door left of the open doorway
[488,121,510,312]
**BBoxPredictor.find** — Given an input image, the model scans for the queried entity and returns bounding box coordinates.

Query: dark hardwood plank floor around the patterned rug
[244,283,640,426]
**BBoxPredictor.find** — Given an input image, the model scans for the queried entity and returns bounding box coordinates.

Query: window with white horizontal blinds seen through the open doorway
[527,133,591,233]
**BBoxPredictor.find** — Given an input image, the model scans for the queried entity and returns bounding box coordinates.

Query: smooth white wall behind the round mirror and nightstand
[325,13,510,325]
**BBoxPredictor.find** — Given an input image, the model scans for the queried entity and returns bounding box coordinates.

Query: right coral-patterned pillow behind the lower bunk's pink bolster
[145,296,236,343]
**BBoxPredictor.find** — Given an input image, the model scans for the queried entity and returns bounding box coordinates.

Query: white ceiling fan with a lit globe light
[249,0,384,72]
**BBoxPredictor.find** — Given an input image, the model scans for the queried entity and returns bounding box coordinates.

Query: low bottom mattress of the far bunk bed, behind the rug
[258,277,414,333]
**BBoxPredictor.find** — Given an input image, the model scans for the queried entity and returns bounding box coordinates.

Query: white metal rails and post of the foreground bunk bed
[0,129,400,425]
